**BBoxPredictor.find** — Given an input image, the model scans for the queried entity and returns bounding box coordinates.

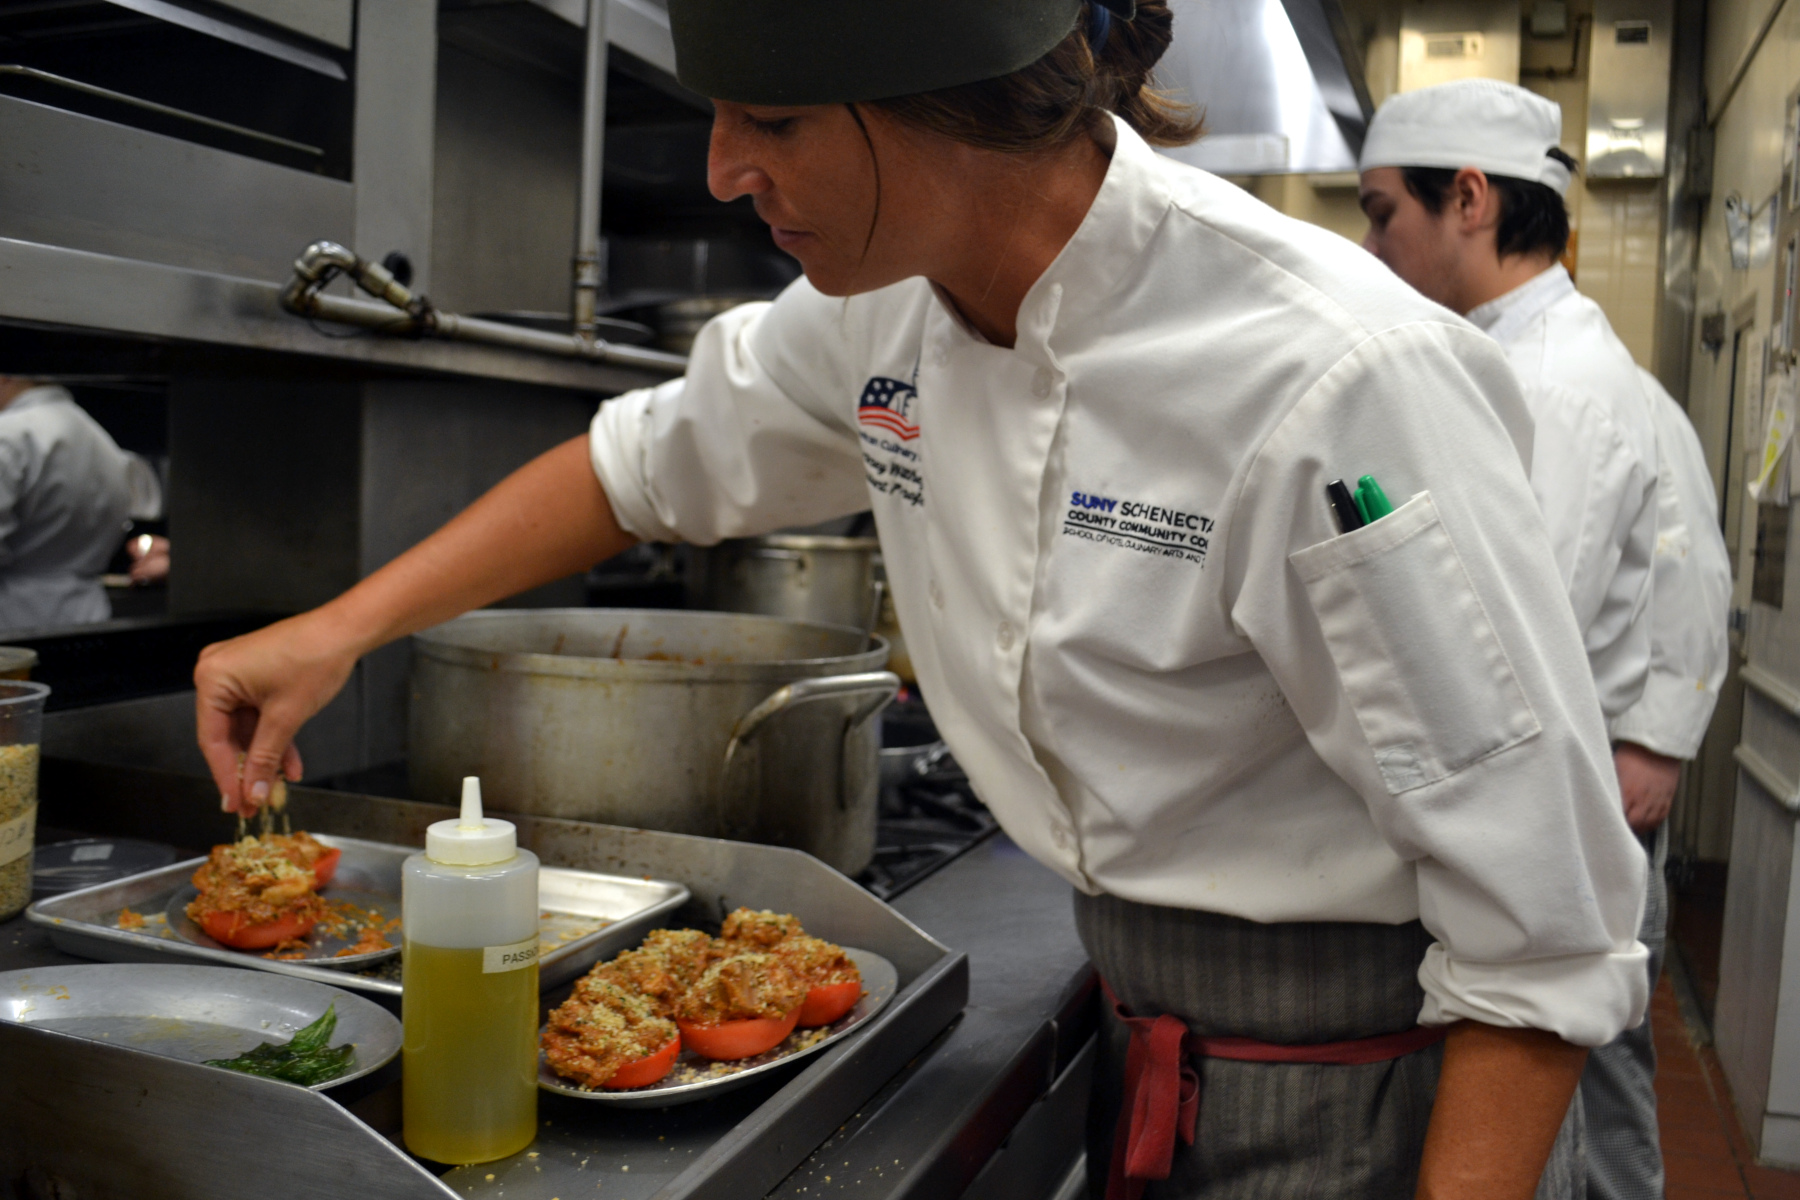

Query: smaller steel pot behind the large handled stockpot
[688,534,882,630]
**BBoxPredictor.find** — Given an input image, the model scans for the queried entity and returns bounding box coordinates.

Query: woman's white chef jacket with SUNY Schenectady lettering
[590,122,1645,1045]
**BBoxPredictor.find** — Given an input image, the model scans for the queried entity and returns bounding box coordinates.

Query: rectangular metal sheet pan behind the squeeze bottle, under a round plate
[25,835,688,997]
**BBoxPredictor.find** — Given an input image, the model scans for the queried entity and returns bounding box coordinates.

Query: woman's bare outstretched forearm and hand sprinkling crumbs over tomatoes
[194,435,635,813]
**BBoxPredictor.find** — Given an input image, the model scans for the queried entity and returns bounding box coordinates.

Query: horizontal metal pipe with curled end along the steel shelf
[281,241,688,374]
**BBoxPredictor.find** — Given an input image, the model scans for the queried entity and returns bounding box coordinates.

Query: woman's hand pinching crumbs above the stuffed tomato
[194,610,358,817]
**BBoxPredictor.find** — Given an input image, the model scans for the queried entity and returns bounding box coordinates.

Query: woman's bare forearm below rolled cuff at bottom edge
[1417,1020,1588,1200]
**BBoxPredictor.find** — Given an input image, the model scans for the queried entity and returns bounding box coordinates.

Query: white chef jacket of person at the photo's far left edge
[0,387,131,635]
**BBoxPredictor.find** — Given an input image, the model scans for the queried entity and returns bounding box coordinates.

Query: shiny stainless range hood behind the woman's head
[1156,0,1373,175]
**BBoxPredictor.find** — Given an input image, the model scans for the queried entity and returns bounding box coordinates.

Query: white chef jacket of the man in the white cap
[1469,264,1656,721]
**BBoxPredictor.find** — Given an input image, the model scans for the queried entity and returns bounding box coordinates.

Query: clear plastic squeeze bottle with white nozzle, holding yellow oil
[401,775,538,1162]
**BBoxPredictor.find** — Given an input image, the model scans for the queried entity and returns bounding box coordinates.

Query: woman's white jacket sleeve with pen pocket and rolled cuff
[1228,322,1649,1045]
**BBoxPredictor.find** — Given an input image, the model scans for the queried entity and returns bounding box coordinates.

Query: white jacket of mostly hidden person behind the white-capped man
[1613,367,1732,759]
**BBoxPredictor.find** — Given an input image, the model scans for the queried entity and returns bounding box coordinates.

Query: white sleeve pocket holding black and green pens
[1289,491,1539,795]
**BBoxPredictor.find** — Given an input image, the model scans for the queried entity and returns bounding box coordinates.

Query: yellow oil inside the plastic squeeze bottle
[401,939,538,1162]
